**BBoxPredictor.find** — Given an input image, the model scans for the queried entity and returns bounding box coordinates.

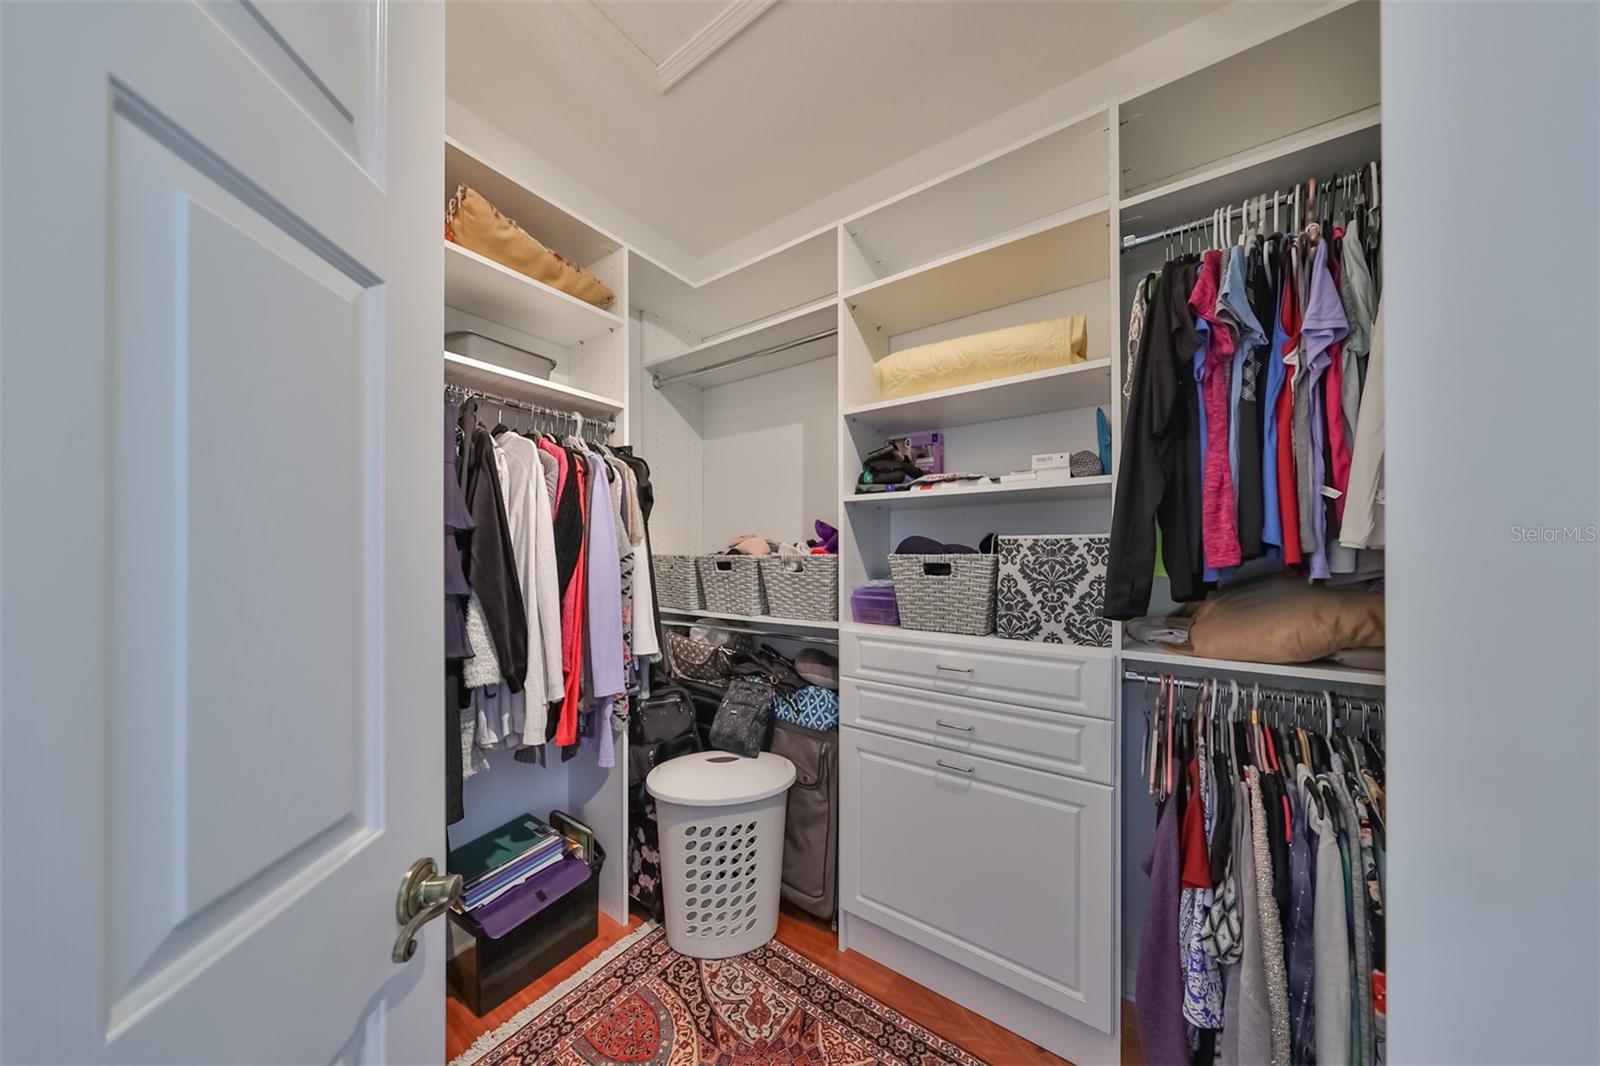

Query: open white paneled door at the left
[0,0,445,1063]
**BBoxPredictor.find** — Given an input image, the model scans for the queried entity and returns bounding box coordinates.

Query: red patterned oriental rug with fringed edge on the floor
[451,927,984,1066]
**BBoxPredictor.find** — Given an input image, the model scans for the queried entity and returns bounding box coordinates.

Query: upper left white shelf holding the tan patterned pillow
[445,240,622,347]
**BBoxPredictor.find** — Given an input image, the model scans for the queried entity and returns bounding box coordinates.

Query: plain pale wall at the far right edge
[1382,3,1600,1063]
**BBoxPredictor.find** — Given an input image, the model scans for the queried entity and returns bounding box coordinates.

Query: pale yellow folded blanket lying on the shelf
[872,315,1088,400]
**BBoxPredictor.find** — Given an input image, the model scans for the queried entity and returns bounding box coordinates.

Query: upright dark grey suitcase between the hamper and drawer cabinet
[773,722,838,919]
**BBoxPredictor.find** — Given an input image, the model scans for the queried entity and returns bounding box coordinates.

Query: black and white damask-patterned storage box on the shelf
[995,535,1110,648]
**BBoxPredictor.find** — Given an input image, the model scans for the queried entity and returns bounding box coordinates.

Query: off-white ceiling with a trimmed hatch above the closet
[446,0,1221,256]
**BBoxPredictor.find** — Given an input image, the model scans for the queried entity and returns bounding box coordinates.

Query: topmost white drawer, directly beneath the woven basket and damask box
[840,626,1115,719]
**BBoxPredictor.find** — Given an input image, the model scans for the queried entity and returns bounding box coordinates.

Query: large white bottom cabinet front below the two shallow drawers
[840,727,1115,1032]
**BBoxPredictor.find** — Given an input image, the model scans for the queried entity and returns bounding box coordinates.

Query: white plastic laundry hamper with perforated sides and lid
[645,751,795,959]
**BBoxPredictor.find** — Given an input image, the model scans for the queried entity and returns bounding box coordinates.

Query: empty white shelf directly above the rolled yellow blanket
[845,197,1110,336]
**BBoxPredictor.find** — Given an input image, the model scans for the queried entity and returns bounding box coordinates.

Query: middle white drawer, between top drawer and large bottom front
[838,677,1115,784]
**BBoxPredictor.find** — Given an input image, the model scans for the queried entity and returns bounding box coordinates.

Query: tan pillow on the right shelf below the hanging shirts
[1189,576,1384,663]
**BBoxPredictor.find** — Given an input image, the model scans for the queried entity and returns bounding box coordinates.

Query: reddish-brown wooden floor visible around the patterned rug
[445,906,1141,1066]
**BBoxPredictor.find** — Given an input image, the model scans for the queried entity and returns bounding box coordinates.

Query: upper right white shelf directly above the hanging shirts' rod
[1120,106,1382,235]
